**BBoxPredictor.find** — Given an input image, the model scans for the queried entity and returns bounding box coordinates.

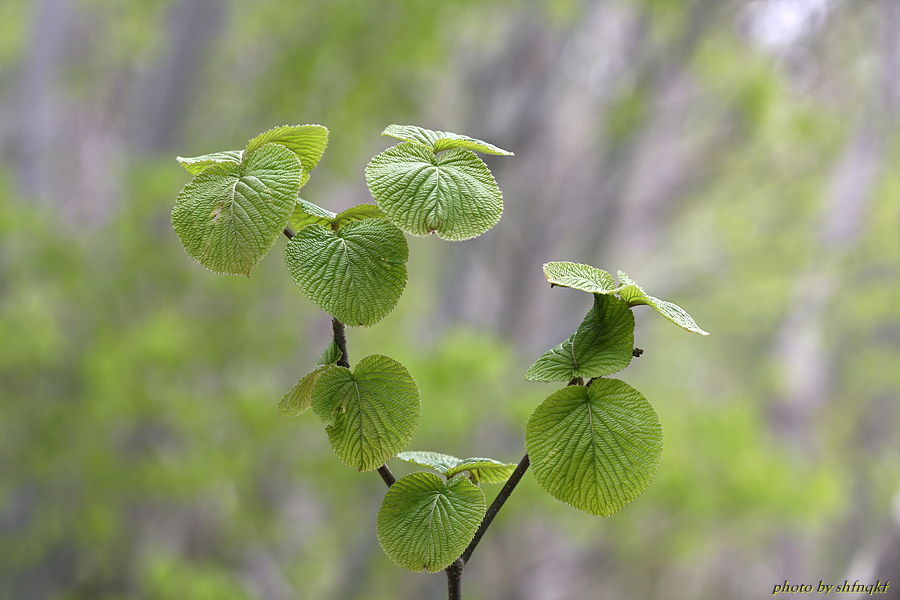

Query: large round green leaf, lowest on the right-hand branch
[525,378,663,517]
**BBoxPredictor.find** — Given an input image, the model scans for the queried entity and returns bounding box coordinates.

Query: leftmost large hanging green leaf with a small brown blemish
[172,144,300,275]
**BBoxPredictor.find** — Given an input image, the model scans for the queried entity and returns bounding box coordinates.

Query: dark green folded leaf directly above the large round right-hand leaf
[525,294,634,381]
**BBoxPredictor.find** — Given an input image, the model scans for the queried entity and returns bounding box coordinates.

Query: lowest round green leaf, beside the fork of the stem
[376,473,487,573]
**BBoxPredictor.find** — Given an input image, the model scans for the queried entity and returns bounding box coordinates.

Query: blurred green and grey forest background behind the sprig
[0,0,900,600]
